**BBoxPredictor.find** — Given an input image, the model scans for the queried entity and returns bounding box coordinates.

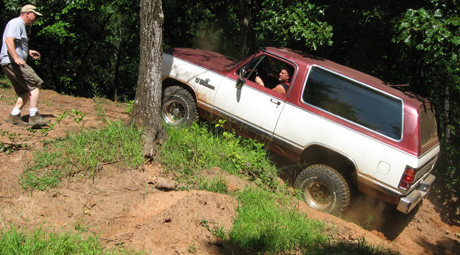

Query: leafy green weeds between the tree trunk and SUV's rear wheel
[161,122,276,185]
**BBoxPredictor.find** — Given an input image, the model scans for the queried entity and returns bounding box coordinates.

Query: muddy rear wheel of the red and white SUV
[295,165,350,215]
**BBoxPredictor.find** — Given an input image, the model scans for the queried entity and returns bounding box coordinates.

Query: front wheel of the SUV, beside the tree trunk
[161,86,198,125]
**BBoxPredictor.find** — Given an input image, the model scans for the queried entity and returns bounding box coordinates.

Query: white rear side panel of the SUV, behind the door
[275,104,439,188]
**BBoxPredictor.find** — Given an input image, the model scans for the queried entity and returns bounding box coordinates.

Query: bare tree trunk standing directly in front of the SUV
[131,0,166,159]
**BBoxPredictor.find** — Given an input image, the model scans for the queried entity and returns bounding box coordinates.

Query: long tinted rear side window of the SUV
[302,66,402,140]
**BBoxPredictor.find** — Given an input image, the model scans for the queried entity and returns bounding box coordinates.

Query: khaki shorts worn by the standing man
[2,64,43,96]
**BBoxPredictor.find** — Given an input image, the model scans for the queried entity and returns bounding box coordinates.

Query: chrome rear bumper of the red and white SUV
[396,174,436,214]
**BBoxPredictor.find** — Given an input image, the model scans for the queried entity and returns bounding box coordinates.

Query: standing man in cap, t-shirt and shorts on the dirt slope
[0,4,50,126]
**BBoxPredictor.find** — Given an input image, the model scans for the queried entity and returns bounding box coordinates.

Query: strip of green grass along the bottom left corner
[0,226,140,255]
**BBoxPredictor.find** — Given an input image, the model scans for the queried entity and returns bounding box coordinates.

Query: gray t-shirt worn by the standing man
[0,17,29,64]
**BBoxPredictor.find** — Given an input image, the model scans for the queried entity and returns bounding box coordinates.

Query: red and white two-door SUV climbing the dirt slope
[162,47,440,214]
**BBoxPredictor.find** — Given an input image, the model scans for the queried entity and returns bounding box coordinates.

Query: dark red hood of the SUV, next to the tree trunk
[165,48,236,72]
